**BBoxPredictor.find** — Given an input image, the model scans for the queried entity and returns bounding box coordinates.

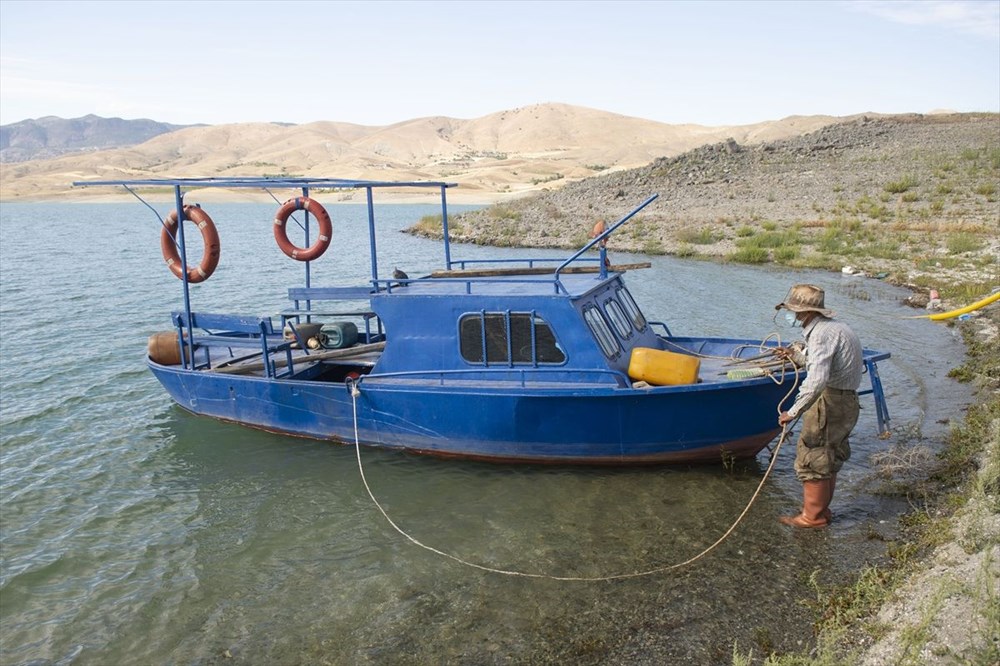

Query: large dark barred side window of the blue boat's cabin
[458,312,566,365]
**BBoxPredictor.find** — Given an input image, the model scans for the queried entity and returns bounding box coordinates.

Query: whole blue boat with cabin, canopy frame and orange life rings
[74,178,889,465]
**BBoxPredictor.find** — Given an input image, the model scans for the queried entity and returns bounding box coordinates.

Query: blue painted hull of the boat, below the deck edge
[149,361,791,465]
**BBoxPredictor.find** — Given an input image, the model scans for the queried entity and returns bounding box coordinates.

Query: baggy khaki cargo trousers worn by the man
[795,387,861,481]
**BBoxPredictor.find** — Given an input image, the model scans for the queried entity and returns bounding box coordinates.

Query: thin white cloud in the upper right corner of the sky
[852,0,1000,39]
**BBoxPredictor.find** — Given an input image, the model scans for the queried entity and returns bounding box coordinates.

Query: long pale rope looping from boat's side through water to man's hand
[351,352,799,582]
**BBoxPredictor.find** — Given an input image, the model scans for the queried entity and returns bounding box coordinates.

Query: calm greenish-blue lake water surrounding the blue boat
[0,202,970,665]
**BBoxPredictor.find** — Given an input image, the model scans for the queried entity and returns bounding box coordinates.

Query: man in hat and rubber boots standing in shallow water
[774,284,862,527]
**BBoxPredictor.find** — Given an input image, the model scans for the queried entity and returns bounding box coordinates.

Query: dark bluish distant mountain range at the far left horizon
[0,115,197,162]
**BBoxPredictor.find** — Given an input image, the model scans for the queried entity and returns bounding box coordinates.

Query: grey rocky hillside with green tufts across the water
[442,114,1000,290]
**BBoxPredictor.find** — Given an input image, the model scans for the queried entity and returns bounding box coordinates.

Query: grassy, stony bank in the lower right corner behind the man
[852,303,1000,666]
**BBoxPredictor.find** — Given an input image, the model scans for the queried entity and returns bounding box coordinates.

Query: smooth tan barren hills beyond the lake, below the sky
[0,104,849,203]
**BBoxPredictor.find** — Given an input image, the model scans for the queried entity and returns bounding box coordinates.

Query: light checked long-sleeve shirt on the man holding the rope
[788,315,863,418]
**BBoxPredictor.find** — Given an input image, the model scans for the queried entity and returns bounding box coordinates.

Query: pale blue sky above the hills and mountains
[0,0,1000,126]
